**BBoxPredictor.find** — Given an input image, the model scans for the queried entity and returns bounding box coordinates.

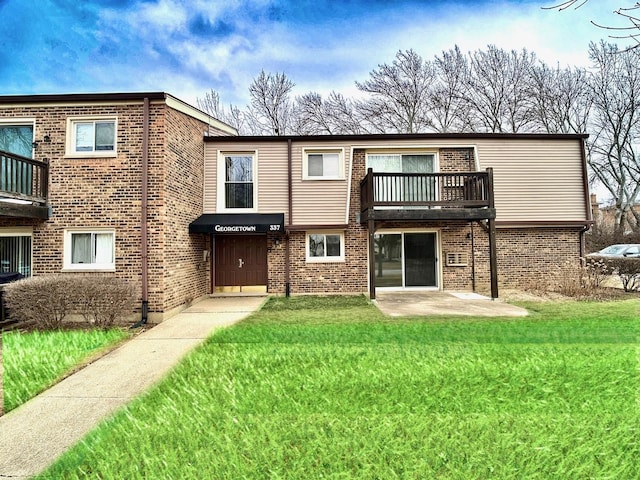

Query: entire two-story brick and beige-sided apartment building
[0,93,591,321]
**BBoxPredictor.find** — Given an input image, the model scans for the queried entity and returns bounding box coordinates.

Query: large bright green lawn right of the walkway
[43,297,640,479]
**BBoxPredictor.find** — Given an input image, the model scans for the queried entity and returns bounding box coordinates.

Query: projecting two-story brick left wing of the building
[0,93,237,320]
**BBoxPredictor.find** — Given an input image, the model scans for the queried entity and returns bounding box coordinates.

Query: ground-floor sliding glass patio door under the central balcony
[375,232,438,288]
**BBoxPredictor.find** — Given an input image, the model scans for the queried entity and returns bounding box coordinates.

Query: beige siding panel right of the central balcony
[478,139,588,222]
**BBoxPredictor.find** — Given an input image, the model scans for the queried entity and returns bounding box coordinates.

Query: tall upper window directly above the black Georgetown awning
[218,152,257,211]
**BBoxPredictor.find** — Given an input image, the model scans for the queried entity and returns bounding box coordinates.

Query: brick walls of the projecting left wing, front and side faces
[0,103,208,313]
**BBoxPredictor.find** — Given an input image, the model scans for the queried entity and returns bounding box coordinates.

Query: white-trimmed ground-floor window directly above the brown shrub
[64,230,116,271]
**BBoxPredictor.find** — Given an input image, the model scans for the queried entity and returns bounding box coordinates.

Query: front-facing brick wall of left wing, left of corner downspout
[0,105,149,307]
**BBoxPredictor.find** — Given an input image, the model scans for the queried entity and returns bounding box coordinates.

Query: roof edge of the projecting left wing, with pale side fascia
[0,92,238,135]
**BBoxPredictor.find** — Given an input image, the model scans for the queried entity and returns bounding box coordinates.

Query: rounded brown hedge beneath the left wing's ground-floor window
[4,275,136,330]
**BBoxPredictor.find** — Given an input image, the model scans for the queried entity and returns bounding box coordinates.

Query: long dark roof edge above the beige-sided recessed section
[205,133,589,143]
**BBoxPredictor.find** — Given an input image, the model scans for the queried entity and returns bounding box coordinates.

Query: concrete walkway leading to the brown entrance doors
[0,297,266,479]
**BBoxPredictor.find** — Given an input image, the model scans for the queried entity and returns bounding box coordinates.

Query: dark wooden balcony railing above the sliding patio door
[360,169,493,212]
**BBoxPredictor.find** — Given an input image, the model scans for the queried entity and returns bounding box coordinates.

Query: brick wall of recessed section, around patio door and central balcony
[262,144,580,294]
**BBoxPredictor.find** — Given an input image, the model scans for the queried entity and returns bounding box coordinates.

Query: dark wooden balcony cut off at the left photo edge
[0,150,49,219]
